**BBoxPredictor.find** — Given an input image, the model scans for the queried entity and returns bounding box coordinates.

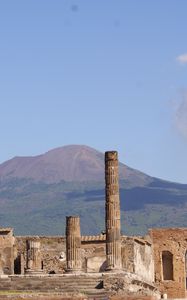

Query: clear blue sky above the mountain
[0,0,187,183]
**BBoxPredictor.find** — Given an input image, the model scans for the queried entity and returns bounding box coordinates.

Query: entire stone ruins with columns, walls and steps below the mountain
[0,151,187,299]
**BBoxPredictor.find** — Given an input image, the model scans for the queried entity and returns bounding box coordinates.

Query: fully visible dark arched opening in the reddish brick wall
[162,251,173,280]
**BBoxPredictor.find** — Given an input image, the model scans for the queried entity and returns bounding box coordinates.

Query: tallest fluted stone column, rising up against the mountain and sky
[105,151,121,270]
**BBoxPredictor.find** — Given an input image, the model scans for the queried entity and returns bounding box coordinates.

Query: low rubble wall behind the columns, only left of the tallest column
[14,235,106,274]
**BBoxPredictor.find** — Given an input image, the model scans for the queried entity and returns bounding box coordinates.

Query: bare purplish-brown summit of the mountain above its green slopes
[0,145,152,186]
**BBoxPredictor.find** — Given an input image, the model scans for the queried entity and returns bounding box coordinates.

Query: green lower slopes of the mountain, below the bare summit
[0,179,187,235]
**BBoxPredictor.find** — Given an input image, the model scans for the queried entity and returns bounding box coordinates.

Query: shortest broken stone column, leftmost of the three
[26,240,42,274]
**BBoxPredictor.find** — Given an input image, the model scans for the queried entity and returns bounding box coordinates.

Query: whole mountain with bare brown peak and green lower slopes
[0,145,187,235]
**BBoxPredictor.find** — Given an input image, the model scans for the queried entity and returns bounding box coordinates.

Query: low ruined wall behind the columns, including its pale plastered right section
[14,235,154,282]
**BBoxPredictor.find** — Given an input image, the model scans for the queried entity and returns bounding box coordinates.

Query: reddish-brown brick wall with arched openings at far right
[149,228,187,298]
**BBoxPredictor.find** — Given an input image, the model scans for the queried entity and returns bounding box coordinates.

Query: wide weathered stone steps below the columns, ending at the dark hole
[0,273,102,294]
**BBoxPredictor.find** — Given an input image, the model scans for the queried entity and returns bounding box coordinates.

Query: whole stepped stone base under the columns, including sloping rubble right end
[0,272,159,300]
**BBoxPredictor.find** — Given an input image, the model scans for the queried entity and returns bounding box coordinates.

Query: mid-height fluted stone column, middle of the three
[66,216,82,273]
